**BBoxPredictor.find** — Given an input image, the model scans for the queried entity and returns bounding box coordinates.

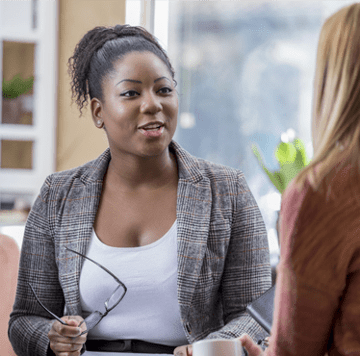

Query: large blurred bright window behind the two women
[159,0,352,253]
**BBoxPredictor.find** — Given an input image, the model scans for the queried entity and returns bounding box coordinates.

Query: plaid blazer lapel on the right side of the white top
[173,142,212,319]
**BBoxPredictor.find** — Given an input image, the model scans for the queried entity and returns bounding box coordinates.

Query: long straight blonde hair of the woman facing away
[296,3,360,189]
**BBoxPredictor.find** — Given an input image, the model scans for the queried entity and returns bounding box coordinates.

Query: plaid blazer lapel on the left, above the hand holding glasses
[57,150,110,315]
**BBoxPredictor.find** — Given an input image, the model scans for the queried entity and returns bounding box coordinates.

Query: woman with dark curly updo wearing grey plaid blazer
[9,25,271,356]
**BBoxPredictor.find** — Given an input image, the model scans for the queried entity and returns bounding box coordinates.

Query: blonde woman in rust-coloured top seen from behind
[241,3,360,356]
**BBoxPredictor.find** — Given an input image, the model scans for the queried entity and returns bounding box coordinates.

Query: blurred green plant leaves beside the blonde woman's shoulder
[251,139,310,193]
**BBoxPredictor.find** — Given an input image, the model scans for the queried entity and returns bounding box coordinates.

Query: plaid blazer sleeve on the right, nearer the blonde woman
[207,172,271,341]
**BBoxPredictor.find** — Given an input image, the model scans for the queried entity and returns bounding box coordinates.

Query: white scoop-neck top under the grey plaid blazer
[80,221,188,346]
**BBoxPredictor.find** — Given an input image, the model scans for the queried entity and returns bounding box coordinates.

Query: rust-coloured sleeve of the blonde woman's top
[266,185,359,356]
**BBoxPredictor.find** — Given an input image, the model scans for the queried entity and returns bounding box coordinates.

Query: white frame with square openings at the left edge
[0,0,58,204]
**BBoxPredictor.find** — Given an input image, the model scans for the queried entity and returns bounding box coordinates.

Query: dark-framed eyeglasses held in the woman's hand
[29,247,127,336]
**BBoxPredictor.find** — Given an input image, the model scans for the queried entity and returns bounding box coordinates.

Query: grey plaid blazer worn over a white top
[9,142,271,356]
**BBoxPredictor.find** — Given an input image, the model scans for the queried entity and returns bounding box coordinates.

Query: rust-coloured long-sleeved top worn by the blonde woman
[266,167,360,356]
